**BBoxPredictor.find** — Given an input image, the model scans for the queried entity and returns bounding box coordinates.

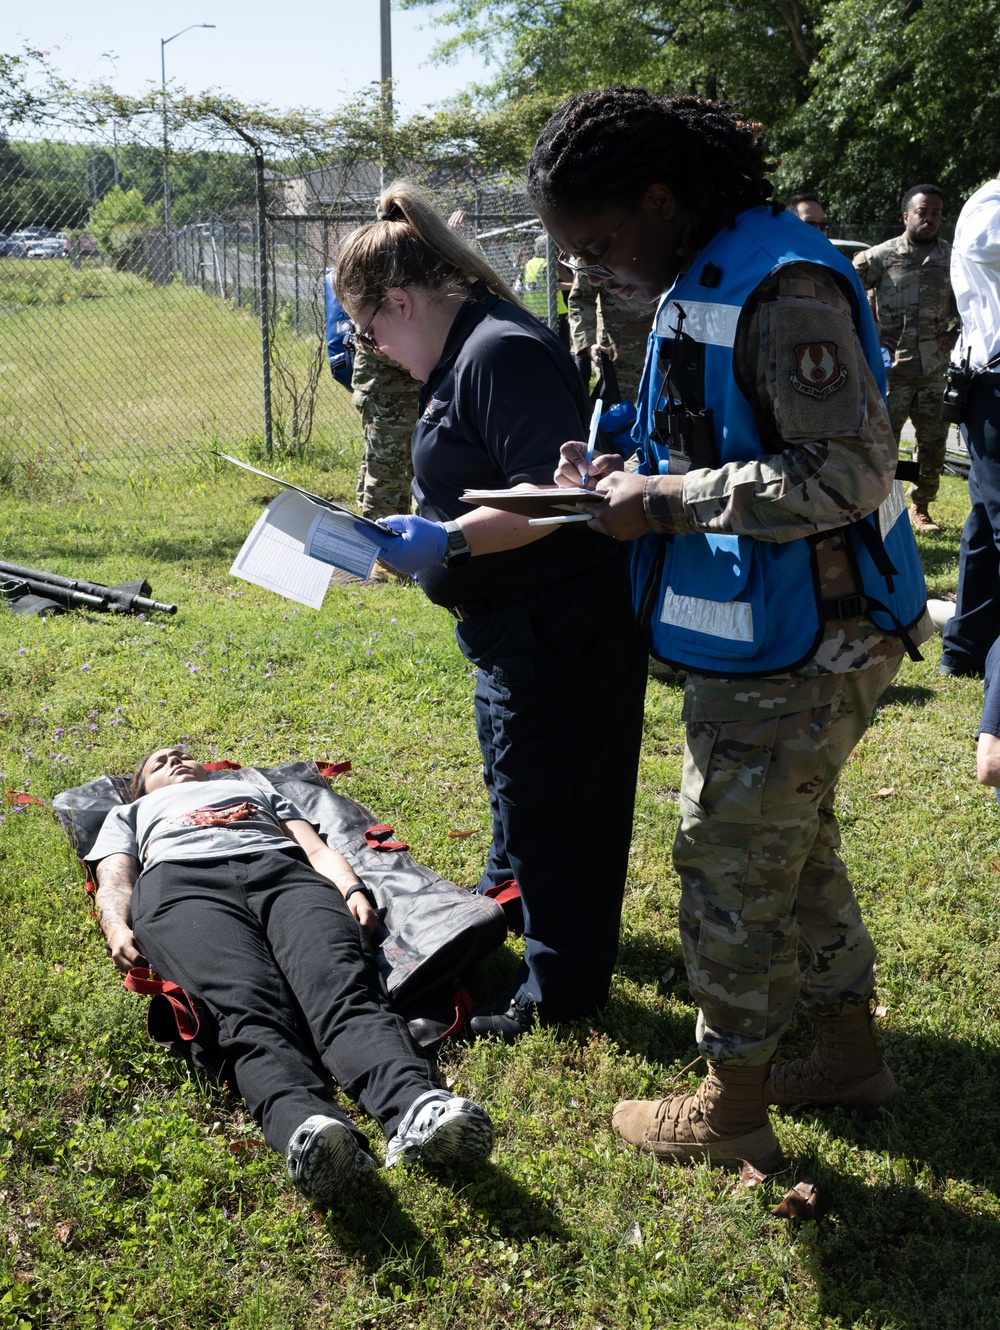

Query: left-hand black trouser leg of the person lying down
[133,855,356,1154]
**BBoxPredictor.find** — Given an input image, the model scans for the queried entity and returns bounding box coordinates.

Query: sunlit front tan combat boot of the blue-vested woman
[612,1063,785,1173]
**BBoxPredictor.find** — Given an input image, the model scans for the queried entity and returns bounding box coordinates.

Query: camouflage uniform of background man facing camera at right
[854,231,959,508]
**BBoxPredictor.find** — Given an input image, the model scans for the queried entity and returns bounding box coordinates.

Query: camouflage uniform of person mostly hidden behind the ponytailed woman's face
[351,346,420,517]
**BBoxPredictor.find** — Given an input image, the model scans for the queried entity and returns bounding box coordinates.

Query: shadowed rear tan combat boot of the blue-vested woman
[766,1007,902,1109]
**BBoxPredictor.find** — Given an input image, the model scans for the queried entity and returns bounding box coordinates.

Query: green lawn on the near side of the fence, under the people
[0,456,1000,1330]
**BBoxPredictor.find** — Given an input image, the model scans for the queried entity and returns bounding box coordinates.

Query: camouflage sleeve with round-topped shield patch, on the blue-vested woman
[644,263,896,543]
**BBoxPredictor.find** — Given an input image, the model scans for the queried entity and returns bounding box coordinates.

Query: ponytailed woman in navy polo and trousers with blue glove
[336,184,645,1040]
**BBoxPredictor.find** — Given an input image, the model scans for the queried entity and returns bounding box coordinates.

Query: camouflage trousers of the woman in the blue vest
[674,658,899,1065]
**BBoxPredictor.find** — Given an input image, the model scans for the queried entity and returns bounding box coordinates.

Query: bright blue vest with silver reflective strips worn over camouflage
[632,206,927,676]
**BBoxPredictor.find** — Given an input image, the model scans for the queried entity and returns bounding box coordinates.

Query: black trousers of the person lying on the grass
[133,850,439,1154]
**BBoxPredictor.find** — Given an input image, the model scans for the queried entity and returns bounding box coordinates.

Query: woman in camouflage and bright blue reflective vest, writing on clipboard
[528,86,930,1170]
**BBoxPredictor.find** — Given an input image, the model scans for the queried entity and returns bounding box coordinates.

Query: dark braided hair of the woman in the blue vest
[528,84,773,259]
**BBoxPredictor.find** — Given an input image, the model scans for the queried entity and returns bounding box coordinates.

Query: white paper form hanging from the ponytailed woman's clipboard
[229,489,332,609]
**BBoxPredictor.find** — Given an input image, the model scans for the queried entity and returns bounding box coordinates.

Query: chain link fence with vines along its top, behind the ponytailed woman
[0,108,537,485]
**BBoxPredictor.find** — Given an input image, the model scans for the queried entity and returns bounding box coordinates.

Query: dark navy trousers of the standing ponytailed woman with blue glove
[456,559,646,1021]
